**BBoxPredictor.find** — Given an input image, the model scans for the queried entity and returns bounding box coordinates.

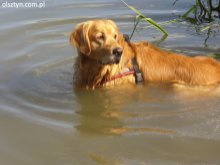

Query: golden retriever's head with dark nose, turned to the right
[70,20,123,64]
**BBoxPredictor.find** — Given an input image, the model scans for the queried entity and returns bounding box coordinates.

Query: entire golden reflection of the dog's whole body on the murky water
[75,80,219,136]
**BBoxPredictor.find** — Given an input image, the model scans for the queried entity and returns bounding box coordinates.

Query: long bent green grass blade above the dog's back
[121,0,168,39]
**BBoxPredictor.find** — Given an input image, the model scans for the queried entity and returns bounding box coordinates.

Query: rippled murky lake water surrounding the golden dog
[0,0,220,165]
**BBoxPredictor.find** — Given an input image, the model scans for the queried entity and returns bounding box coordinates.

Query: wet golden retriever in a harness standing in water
[70,19,220,89]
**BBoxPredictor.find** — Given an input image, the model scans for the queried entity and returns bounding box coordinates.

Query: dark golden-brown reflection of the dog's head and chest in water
[76,87,126,135]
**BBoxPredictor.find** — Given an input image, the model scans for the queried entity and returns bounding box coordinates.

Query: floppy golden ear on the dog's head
[70,21,91,55]
